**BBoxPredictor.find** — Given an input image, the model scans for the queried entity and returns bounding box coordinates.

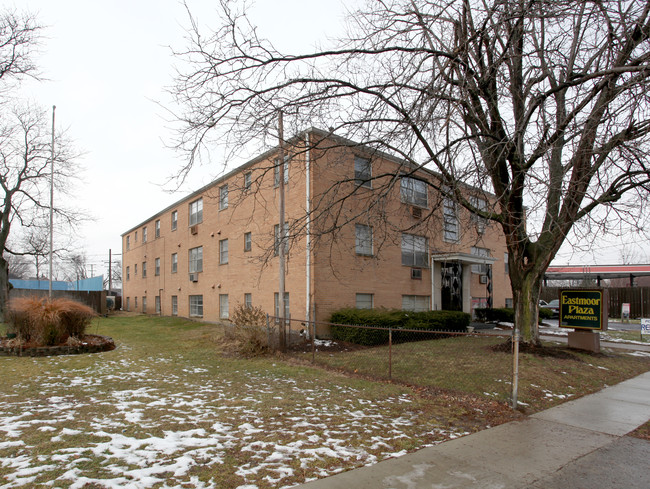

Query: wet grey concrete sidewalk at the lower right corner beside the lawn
[296,372,650,489]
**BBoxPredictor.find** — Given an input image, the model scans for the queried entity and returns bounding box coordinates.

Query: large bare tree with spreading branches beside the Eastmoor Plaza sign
[172,0,650,342]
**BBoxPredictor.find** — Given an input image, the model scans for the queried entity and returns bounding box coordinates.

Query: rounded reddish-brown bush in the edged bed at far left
[8,297,96,345]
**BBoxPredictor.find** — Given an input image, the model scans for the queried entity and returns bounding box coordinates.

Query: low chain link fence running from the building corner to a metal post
[267,316,518,405]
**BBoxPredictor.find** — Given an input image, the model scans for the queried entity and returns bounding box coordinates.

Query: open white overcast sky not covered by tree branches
[15,0,650,274]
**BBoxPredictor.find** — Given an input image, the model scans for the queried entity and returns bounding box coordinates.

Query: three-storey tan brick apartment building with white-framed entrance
[122,128,511,321]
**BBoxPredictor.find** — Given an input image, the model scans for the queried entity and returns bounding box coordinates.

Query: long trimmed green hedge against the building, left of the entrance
[330,308,470,346]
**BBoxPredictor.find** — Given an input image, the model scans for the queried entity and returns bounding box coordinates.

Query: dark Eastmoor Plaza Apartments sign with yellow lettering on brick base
[559,289,607,353]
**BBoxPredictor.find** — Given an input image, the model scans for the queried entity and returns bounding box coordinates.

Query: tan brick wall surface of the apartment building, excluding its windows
[123,131,511,321]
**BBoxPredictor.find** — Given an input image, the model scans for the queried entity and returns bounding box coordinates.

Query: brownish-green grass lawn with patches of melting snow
[0,315,650,489]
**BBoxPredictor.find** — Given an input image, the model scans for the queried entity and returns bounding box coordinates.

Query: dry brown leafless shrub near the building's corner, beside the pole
[229,304,269,357]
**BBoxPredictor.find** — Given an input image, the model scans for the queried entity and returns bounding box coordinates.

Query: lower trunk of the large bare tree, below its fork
[510,273,542,345]
